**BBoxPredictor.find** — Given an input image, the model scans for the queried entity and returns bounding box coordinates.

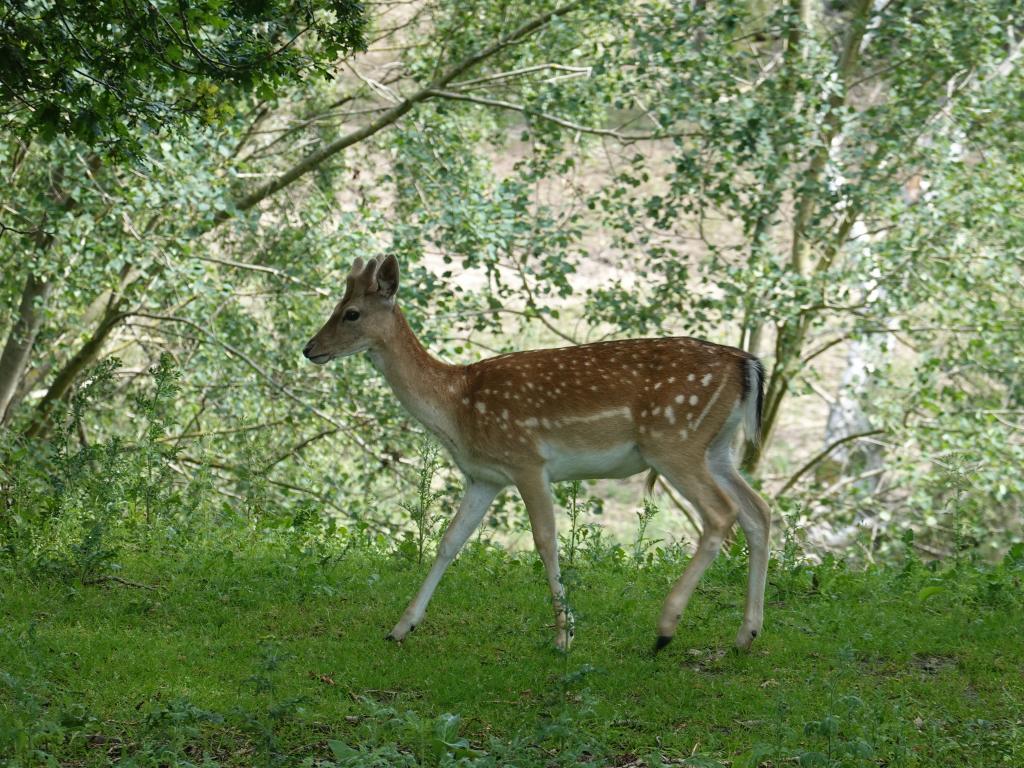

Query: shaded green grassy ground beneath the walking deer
[0,545,1024,767]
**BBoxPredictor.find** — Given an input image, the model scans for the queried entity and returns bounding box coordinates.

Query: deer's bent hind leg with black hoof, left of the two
[652,458,737,651]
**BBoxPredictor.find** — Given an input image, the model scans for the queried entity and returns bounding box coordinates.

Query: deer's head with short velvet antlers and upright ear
[302,256,398,366]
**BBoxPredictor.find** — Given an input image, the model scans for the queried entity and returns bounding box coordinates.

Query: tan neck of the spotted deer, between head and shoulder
[370,308,463,449]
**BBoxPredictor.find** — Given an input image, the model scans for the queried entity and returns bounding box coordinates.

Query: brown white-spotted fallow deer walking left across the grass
[303,256,770,650]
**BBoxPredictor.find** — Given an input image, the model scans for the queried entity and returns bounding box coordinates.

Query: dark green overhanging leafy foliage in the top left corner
[0,0,366,151]
